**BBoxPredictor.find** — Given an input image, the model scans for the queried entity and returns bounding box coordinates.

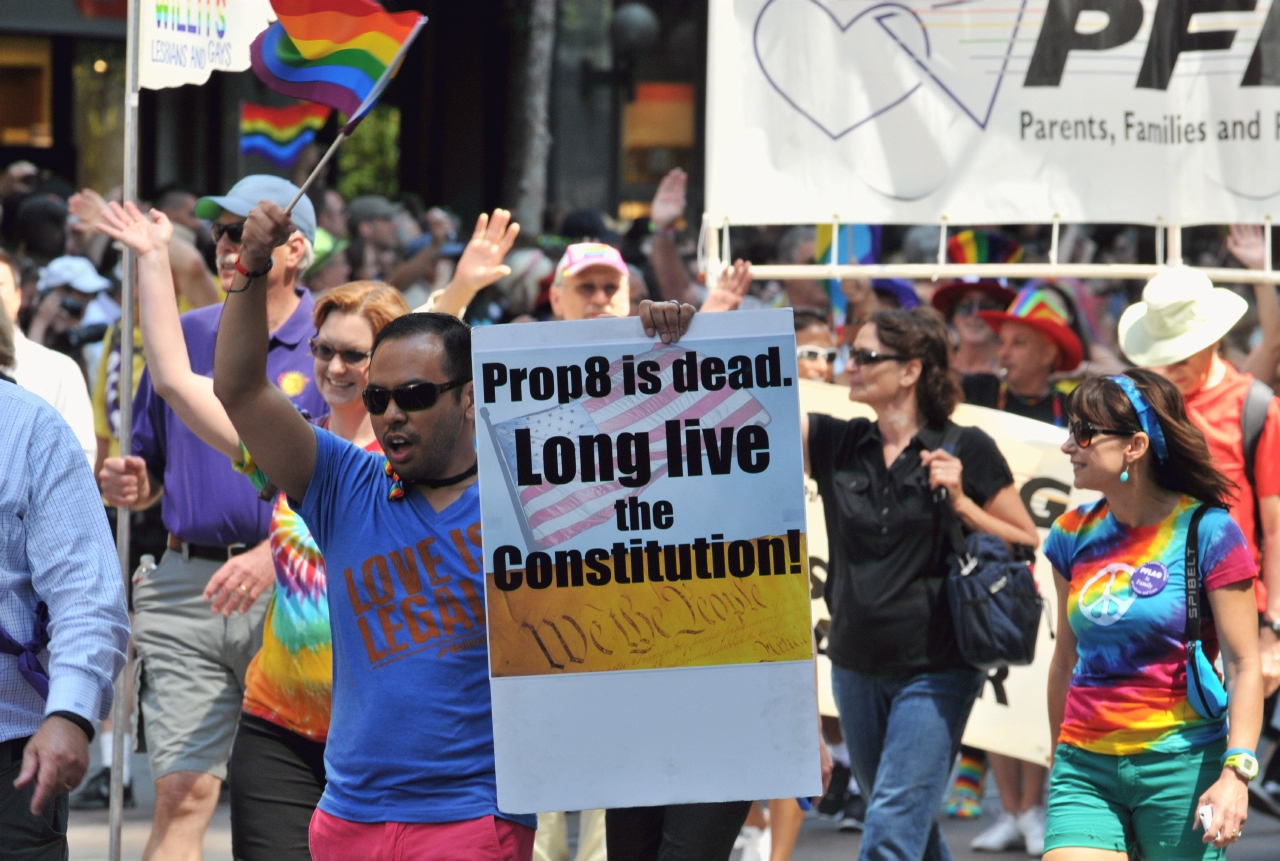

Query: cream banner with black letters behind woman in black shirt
[800,380,1097,764]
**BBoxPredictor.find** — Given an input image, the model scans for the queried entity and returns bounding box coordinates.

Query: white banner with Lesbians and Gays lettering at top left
[138,0,275,90]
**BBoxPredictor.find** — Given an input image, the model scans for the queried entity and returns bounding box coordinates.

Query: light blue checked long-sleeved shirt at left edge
[0,383,129,741]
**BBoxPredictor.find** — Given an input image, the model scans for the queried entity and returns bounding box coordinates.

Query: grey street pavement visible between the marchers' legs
[68,755,1280,861]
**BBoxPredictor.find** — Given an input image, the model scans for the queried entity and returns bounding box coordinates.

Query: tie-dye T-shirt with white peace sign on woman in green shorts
[1044,496,1257,756]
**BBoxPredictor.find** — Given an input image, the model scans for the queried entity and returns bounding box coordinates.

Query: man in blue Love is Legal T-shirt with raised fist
[215,202,687,861]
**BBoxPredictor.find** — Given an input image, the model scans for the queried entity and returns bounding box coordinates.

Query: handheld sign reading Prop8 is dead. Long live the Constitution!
[472,311,820,812]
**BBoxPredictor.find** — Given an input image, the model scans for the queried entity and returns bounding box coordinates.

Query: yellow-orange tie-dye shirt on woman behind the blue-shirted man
[244,494,333,742]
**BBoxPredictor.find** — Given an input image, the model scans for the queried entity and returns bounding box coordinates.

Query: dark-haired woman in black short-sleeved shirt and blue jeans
[801,308,1038,861]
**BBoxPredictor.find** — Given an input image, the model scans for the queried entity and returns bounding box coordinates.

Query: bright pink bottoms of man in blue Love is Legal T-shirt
[308,807,534,861]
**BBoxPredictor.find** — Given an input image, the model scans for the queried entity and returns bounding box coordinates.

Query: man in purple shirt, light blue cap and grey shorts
[101,175,328,861]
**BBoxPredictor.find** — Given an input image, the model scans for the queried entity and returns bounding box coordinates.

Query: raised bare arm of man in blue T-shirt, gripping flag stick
[214,201,316,500]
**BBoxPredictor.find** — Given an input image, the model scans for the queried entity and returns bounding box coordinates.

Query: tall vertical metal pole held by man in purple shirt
[108,0,140,861]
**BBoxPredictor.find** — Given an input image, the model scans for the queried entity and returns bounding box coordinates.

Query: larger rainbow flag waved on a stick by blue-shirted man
[250,0,426,133]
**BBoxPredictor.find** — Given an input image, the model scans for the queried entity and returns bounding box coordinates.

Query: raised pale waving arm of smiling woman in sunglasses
[99,202,241,459]
